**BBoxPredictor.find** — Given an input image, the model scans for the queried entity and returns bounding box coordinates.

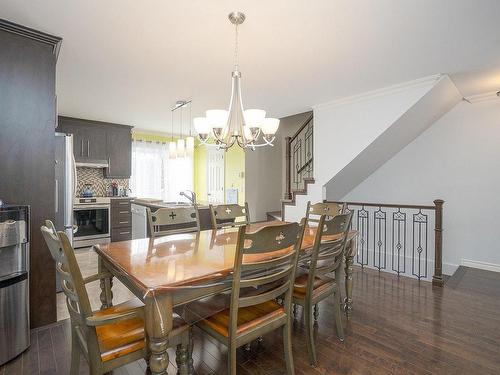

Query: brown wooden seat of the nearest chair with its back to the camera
[199,301,285,337]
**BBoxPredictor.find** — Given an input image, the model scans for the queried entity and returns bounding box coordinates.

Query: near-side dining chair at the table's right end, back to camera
[293,212,352,366]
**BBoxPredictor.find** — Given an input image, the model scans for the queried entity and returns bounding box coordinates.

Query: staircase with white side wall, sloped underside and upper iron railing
[282,75,461,221]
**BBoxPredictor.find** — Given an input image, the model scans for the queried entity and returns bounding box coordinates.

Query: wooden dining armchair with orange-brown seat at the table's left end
[41,221,192,375]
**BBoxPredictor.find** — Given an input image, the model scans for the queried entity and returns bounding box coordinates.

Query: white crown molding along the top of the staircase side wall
[312,74,442,110]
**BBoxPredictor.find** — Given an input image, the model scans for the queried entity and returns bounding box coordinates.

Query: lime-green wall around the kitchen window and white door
[132,132,245,205]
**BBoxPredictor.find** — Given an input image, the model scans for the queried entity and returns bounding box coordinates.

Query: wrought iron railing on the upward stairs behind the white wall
[285,115,314,199]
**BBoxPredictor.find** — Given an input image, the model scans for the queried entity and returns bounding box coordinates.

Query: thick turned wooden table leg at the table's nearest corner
[144,293,173,375]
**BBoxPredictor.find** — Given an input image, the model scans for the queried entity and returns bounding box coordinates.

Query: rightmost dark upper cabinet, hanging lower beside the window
[104,126,132,178]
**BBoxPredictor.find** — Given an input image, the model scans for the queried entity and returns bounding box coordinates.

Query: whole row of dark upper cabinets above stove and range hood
[57,116,132,178]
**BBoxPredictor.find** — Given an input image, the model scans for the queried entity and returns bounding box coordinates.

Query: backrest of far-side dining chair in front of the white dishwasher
[146,205,200,238]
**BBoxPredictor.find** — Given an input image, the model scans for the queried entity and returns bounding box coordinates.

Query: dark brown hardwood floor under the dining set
[0,267,500,375]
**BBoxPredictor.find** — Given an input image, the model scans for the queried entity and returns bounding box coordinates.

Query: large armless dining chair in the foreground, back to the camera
[197,221,305,375]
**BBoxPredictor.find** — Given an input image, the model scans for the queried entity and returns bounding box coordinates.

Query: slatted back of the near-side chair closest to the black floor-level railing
[301,211,352,295]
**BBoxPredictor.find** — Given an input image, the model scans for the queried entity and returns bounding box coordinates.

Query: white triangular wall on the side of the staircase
[285,77,438,221]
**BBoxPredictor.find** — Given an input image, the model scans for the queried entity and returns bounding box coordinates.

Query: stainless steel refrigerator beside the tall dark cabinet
[54,133,76,292]
